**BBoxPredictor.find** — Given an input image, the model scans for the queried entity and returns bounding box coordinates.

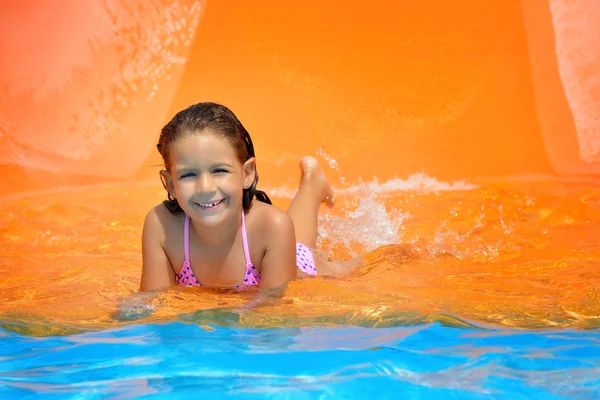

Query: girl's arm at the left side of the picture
[140,206,176,292]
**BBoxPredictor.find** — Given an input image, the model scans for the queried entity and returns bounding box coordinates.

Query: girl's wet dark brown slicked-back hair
[156,103,272,212]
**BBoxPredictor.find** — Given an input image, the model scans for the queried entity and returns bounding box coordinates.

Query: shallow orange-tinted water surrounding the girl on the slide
[0,174,600,334]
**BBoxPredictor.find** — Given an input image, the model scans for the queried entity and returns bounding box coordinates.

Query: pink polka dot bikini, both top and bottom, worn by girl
[177,213,317,290]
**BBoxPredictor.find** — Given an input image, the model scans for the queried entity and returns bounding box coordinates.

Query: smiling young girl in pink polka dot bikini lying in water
[141,103,345,291]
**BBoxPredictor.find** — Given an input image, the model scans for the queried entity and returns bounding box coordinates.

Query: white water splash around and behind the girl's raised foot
[268,148,488,260]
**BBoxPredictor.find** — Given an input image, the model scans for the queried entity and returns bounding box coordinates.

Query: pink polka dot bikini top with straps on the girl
[177,211,260,290]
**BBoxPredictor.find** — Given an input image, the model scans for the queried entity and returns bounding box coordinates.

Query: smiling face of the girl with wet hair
[165,132,255,225]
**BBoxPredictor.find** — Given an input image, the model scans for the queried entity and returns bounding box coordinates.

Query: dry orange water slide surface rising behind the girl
[0,0,600,193]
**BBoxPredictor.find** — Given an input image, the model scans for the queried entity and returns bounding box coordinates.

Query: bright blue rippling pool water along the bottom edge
[0,322,600,399]
